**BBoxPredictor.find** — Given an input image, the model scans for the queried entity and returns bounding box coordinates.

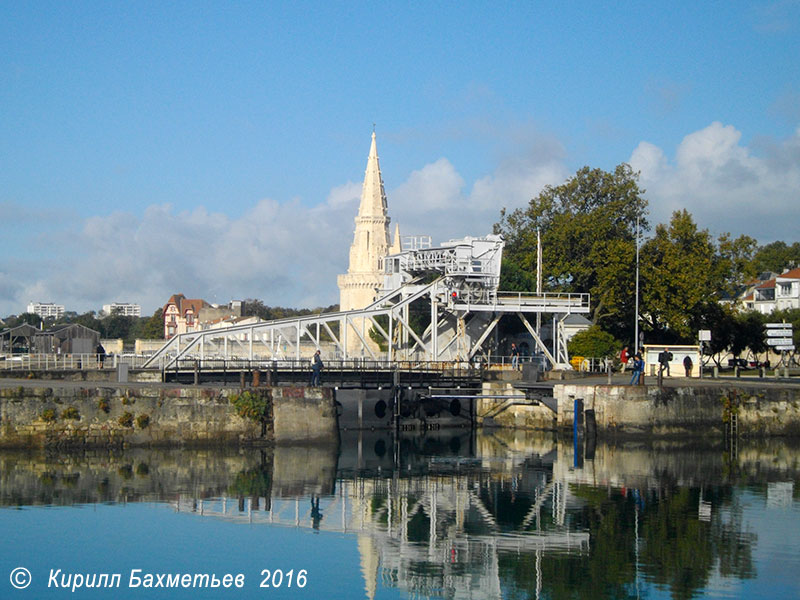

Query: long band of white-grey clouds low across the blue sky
[0,122,800,315]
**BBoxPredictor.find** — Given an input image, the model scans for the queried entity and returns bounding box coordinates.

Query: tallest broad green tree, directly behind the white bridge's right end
[494,164,649,337]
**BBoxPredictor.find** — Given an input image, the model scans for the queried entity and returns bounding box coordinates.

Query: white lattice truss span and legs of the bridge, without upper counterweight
[145,277,589,369]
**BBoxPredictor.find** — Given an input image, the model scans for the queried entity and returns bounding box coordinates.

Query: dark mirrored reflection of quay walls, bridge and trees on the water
[0,432,800,599]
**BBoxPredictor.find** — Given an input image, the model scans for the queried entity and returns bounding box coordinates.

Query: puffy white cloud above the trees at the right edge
[630,122,800,243]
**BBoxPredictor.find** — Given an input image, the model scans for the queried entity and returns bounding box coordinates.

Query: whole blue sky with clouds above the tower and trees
[0,0,800,316]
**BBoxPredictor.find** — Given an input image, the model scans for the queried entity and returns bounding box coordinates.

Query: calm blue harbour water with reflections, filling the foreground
[0,432,800,599]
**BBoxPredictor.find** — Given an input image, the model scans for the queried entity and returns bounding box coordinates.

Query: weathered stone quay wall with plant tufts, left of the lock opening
[0,382,338,448]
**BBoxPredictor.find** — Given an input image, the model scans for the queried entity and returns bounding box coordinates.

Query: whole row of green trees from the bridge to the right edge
[494,164,800,356]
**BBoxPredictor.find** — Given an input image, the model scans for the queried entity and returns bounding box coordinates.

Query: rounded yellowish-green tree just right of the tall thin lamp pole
[641,209,720,342]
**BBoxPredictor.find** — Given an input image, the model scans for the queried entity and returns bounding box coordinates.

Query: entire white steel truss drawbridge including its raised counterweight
[144,236,590,371]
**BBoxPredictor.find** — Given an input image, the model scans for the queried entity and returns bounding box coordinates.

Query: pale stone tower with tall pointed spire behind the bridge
[337,131,390,354]
